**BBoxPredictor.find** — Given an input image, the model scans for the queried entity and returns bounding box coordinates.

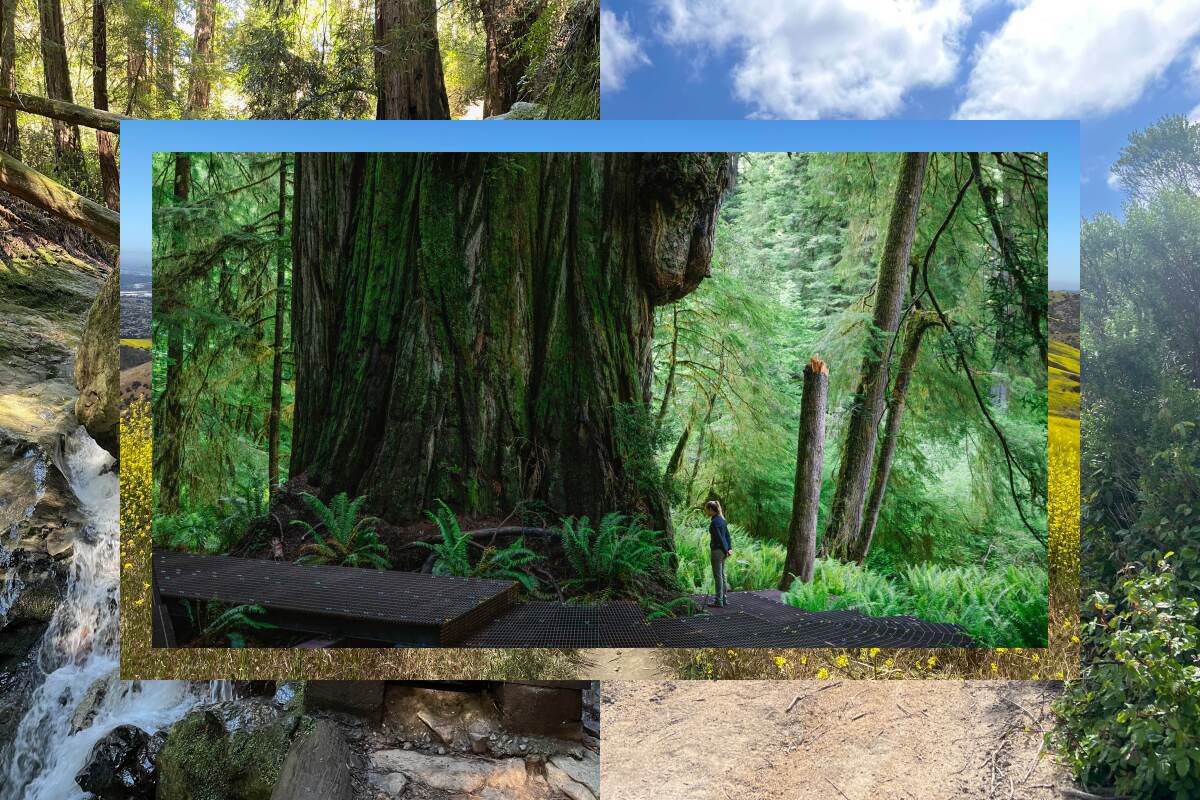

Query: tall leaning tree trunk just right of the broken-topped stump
[824,152,929,559]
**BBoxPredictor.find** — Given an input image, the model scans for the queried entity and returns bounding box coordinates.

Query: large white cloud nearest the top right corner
[956,0,1200,119]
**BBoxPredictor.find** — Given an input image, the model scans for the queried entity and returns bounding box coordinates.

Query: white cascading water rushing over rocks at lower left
[0,427,228,800]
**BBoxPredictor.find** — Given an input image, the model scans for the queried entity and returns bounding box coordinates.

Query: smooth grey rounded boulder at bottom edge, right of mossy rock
[271,720,354,800]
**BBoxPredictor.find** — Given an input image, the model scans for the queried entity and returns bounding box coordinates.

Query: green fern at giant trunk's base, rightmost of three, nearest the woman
[562,513,671,595]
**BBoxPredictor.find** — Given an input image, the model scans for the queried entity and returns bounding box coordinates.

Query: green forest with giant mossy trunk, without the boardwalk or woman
[152,154,1051,646]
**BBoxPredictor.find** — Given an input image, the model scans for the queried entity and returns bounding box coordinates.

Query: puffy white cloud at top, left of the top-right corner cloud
[656,0,986,119]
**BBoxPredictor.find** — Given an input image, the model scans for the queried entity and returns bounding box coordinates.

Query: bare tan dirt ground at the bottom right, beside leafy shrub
[601,681,1074,800]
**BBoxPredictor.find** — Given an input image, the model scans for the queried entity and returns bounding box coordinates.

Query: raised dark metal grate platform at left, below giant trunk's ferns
[154,553,517,645]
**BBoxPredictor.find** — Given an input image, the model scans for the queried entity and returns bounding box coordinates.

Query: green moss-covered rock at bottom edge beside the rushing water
[158,699,313,800]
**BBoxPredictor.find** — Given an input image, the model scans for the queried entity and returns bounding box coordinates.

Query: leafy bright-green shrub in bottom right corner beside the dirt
[1048,553,1200,800]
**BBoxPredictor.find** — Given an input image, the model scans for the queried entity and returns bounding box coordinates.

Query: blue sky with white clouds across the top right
[601,0,1200,287]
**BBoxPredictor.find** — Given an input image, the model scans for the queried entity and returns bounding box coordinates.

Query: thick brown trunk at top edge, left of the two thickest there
[376,0,450,120]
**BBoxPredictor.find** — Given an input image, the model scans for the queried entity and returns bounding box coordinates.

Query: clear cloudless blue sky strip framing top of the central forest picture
[121,120,1080,291]
